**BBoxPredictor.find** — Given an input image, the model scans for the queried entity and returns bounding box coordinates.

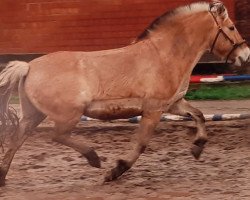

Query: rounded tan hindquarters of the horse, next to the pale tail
[24,57,92,123]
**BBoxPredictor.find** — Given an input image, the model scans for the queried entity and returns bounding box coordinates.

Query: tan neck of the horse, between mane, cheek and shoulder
[150,13,214,73]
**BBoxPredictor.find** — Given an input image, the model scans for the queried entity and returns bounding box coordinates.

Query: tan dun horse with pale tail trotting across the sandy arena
[0,1,250,185]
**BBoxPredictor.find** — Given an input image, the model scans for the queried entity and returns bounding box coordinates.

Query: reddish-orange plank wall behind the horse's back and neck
[0,0,235,54]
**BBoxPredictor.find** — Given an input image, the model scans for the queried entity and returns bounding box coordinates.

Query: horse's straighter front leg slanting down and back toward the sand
[105,111,162,182]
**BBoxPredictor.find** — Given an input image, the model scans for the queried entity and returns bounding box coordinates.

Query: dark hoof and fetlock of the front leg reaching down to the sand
[104,160,130,182]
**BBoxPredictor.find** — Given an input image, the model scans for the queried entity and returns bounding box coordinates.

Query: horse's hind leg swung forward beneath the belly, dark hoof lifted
[53,122,101,168]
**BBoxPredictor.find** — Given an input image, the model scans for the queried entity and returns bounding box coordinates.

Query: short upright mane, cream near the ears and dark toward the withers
[134,2,210,42]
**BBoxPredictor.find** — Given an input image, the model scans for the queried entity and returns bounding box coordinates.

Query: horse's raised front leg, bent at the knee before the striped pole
[168,99,207,159]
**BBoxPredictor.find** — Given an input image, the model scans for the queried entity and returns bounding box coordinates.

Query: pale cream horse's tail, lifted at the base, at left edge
[0,61,29,150]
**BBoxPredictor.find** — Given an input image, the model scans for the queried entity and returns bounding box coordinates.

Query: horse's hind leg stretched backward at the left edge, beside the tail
[0,94,46,186]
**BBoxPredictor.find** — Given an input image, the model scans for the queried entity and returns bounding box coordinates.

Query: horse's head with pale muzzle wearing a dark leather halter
[210,1,250,66]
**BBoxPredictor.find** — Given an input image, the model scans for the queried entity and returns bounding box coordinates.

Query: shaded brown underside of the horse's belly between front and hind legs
[84,99,142,120]
